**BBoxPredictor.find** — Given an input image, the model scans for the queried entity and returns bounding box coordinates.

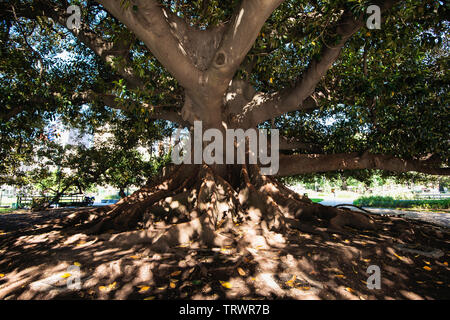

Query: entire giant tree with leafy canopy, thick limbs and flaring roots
[0,0,449,249]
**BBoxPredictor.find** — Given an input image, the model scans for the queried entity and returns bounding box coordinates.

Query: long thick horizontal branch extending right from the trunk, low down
[277,153,450,176]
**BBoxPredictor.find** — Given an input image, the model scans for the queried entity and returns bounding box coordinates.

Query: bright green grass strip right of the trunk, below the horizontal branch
[353,196,450,209]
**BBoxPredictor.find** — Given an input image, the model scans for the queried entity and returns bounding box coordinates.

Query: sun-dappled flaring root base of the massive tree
[59,165,375,251]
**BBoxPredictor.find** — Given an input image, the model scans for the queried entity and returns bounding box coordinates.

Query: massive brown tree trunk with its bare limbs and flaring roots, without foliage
[55,0,444,250]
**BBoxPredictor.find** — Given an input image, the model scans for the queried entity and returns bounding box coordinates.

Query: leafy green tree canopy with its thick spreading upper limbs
[0,0,450,181]
